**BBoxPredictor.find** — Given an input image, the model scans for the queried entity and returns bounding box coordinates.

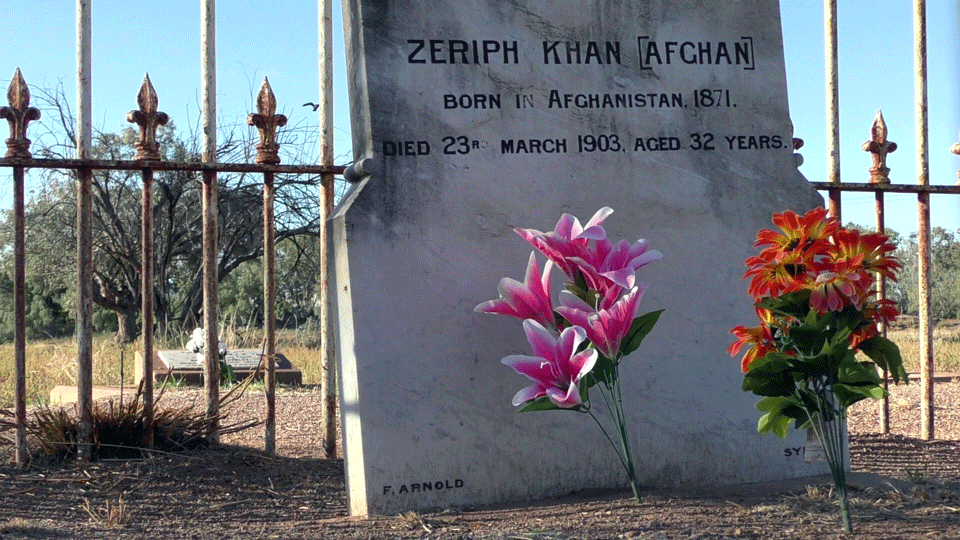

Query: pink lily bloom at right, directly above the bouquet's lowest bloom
[557,283,649,360]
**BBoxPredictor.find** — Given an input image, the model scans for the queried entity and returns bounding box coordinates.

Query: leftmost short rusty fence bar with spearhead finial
[0,68,40,465]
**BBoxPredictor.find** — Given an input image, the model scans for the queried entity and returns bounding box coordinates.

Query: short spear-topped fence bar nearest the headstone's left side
[247,77,287,455]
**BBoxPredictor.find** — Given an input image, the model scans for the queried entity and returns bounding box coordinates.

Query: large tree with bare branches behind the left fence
[0,82,321,342]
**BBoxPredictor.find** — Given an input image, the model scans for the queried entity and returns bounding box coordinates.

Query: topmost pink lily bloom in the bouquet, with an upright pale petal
[514,206,613,279]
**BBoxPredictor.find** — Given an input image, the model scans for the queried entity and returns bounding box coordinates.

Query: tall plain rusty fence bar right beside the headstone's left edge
[317,0,337,458]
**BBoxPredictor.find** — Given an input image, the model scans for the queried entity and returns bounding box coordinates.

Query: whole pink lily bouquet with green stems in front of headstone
[474,207,663,501]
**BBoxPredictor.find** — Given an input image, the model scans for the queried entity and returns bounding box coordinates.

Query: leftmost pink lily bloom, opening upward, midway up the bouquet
[473,251,556,328]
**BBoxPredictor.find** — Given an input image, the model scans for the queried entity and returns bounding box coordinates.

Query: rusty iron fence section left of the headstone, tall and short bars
[0,0,349,464]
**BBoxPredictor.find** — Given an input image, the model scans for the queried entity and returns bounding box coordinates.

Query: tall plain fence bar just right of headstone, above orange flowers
[823,0,841,220]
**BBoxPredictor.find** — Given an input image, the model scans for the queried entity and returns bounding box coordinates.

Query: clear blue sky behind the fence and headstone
[0,0,960,233]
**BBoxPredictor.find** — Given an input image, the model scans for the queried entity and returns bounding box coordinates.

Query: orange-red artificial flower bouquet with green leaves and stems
[729,208,907,532]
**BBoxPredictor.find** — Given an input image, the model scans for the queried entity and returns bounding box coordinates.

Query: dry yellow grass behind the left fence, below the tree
[0,328,322,409]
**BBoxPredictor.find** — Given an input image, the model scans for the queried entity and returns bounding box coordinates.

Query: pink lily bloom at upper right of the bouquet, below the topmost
[571,238,663,293]
